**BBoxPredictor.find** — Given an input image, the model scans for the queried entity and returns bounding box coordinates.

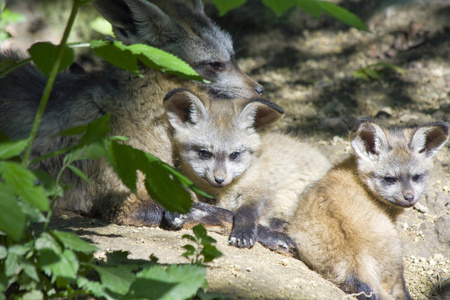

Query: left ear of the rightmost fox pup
[350,117,389,159]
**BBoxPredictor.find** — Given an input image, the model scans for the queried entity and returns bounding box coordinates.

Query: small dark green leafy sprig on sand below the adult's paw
[183,224,222,266]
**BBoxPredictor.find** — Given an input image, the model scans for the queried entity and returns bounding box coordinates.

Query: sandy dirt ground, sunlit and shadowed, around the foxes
[1,0,450,299]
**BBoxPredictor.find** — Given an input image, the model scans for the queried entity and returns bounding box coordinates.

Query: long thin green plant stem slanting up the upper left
[22,0,82,167]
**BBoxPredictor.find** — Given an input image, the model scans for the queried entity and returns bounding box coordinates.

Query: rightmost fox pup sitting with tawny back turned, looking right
[286,118,448,299]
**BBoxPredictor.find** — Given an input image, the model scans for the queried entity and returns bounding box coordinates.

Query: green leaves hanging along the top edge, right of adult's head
[213,0,369,31]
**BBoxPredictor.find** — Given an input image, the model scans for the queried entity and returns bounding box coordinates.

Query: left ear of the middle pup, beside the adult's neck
[163,89,209,128]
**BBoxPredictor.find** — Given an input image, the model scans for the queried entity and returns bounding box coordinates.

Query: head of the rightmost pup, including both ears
[351,118,449,207]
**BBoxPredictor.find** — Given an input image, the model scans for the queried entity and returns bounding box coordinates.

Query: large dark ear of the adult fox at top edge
[92,0,177,46]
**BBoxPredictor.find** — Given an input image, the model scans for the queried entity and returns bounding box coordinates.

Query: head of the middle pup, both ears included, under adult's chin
[164,89,283,188]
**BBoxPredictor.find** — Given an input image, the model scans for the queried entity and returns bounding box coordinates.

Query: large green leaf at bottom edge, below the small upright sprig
[127,265,206,300]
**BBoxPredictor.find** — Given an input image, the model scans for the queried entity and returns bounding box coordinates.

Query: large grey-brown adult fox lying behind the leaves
[0,0,263,225]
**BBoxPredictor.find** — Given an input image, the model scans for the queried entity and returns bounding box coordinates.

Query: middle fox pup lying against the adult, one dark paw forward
[164,90,330,247]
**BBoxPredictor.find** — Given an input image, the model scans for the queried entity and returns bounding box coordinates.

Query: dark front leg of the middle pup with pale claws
[228,204,261,248]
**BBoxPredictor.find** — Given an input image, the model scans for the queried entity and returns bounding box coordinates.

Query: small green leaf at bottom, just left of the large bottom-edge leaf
[90,264,135,295]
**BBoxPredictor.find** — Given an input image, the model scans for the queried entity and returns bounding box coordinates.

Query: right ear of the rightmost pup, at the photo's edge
[409,122,449,157]
